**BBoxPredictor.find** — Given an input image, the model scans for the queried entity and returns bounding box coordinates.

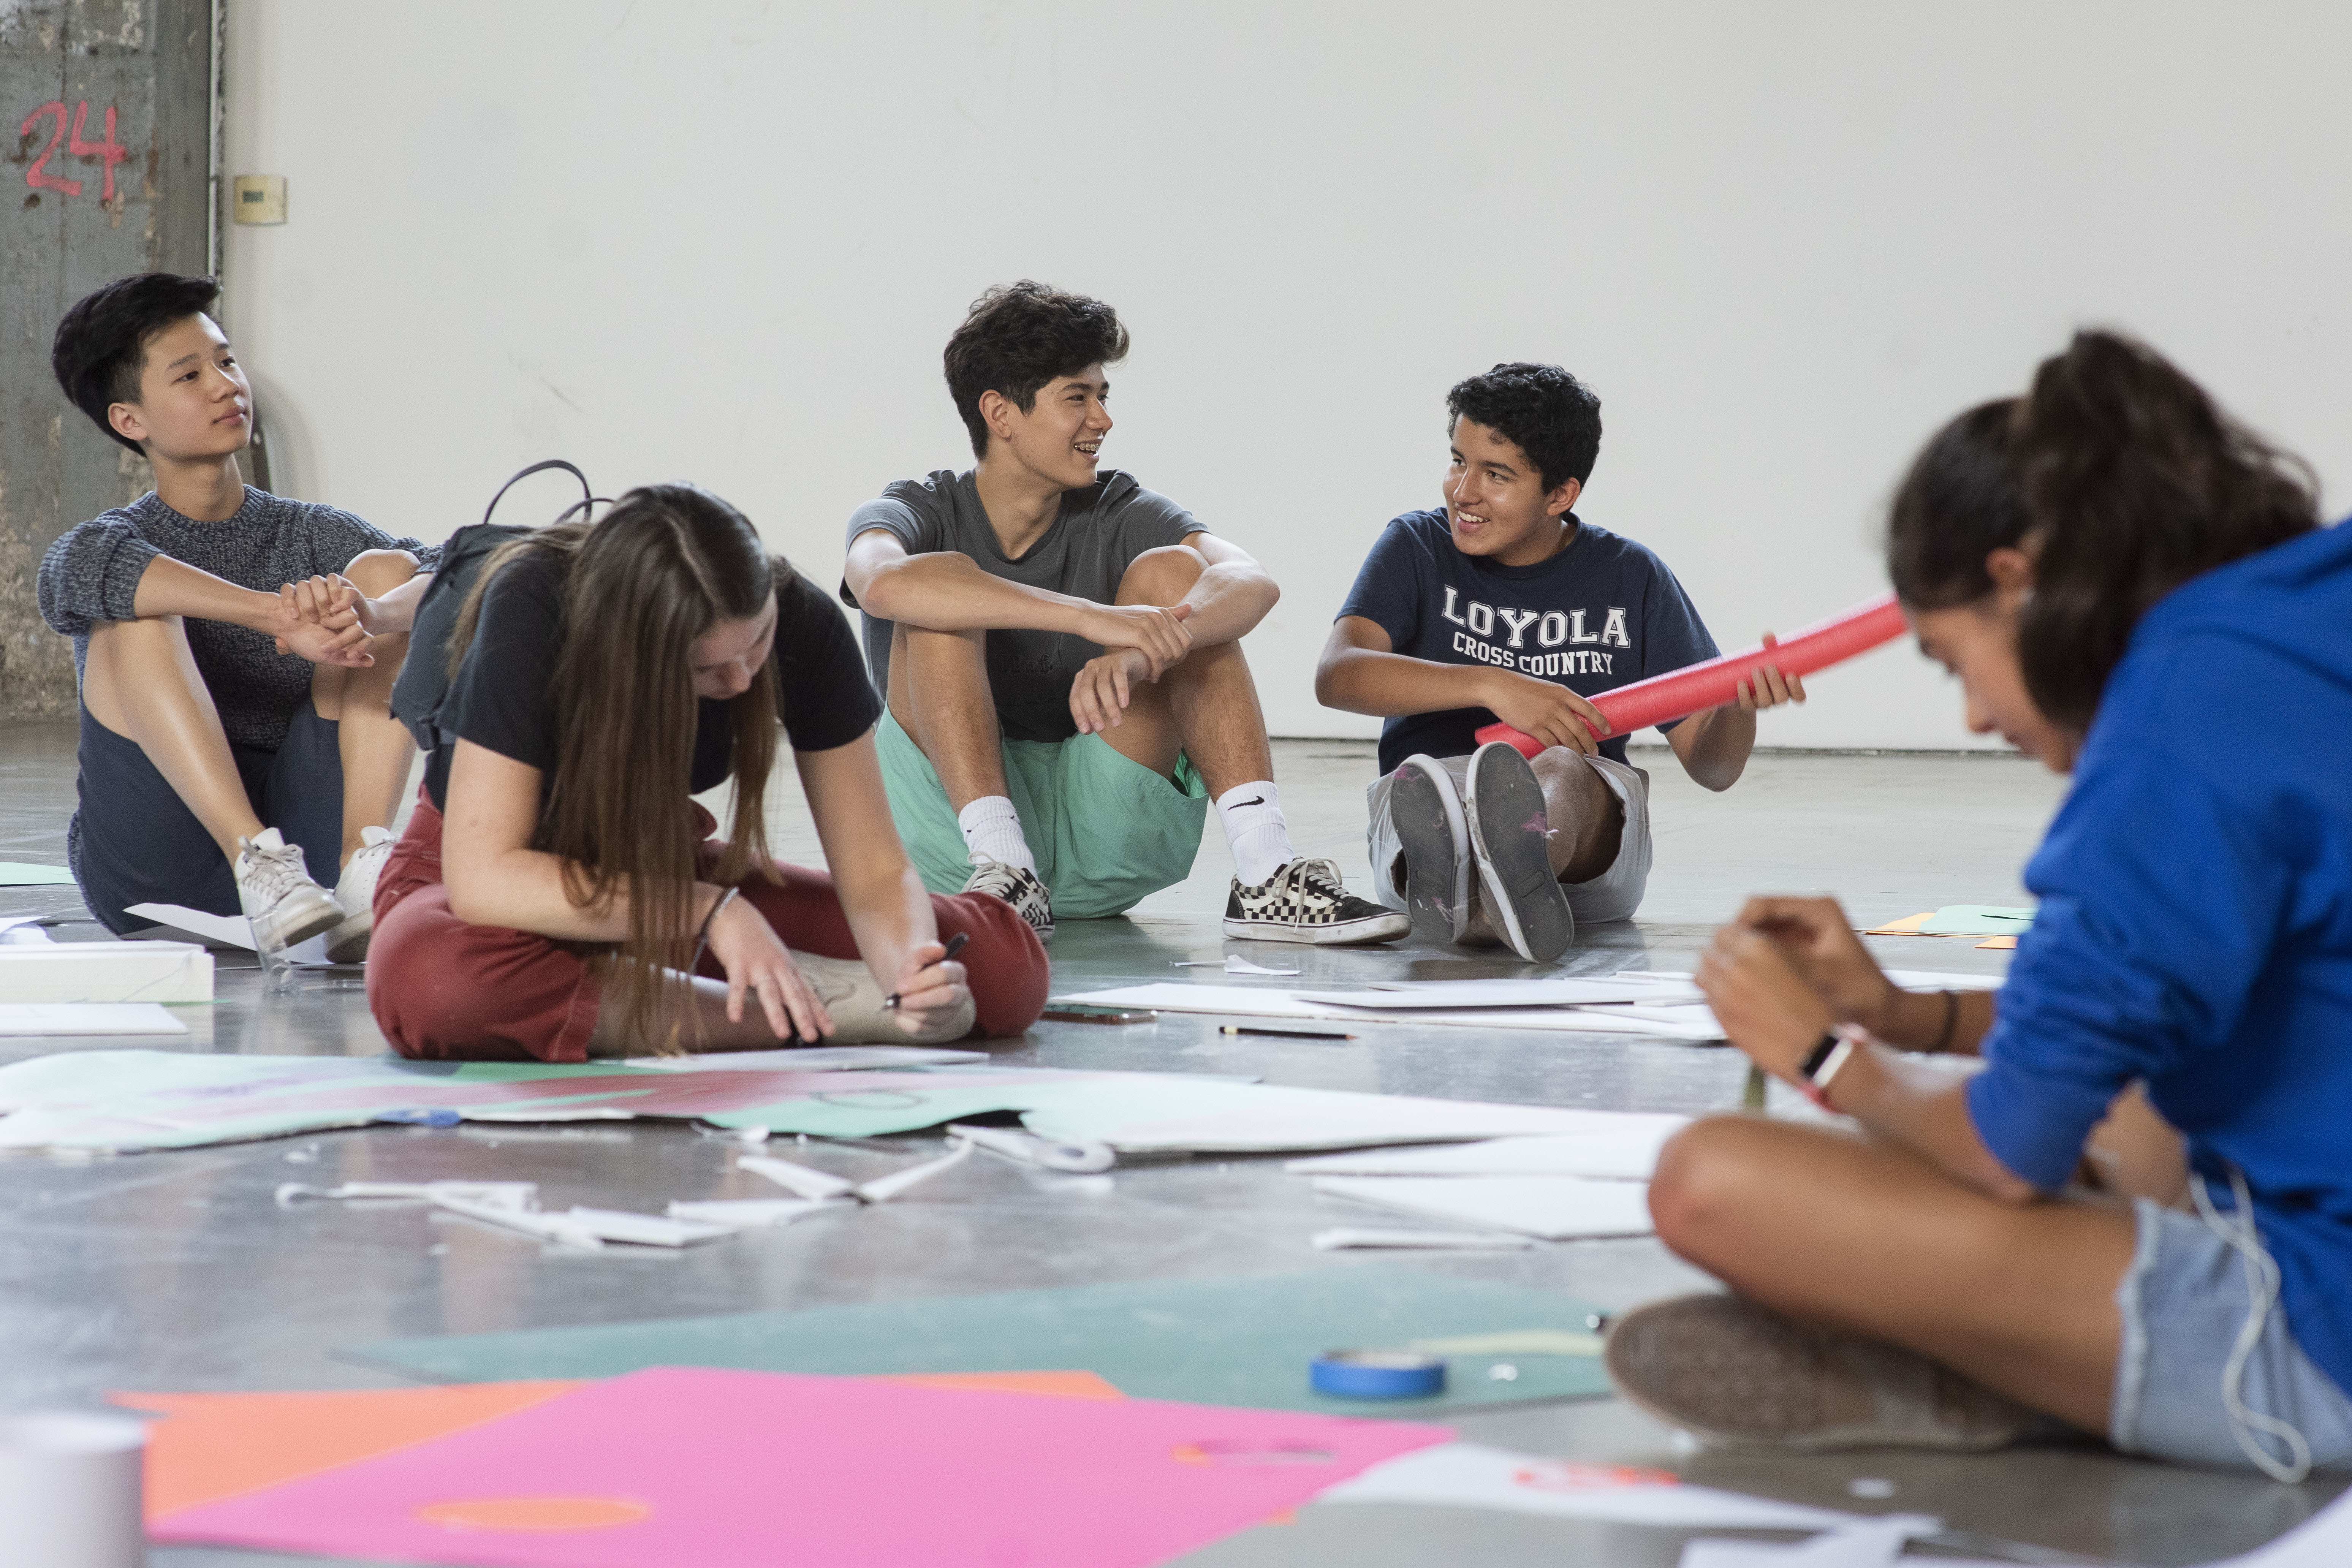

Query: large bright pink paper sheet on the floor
[153,1366,1451,1568]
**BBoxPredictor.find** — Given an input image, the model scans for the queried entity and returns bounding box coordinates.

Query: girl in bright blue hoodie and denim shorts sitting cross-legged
[1609,334,2352,1479]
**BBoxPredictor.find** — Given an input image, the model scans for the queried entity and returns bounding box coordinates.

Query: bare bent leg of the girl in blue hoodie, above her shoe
[1649,1117,2133,1432]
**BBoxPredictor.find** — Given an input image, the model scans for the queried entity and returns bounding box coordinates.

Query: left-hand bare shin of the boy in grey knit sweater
[82,616,261,865]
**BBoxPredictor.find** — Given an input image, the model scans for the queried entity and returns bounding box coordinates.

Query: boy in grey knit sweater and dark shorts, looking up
[40,273,440,964]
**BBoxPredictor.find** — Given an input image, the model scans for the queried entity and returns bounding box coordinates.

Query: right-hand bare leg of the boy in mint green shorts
[1103,545,1275,799]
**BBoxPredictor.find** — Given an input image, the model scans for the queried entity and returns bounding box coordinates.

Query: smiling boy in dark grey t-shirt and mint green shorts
[842,282,1411,943]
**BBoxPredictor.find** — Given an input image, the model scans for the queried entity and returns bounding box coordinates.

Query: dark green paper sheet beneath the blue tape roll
[336,1265,1609,1420]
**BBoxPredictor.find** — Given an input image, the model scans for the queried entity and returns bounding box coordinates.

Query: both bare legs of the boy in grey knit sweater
[82,550,416,881]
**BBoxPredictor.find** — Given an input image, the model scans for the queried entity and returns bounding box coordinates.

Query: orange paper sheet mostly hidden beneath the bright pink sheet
[108,1370,1127,1528]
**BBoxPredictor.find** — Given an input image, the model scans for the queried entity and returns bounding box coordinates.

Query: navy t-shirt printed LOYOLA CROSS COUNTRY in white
[1338,513,1717,774]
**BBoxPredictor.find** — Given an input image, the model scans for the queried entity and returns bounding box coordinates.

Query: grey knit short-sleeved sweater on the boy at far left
[38,484,440,752]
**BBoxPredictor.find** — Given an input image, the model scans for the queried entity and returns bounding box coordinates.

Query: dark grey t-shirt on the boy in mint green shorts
[842,468,1209,740]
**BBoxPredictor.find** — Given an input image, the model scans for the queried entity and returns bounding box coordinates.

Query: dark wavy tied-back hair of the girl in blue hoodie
[1886,331,2319,733]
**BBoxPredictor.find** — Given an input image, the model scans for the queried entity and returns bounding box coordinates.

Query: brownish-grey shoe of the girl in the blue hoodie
[1602,1295,2053,1453]
